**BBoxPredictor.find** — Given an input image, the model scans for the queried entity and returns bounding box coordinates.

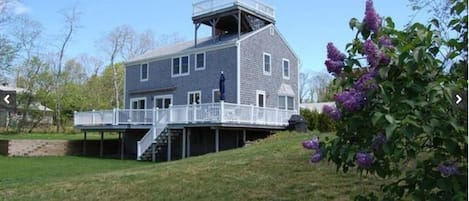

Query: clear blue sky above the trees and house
[17,0,426,72]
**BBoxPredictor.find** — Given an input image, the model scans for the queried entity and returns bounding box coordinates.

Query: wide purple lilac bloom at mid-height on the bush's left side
[334,88,365,112]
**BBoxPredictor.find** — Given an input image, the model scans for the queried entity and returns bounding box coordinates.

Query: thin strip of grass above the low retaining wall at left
[0,133,118,140]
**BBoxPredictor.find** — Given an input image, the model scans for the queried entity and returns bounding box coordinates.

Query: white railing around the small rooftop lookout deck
[192,0,275,19]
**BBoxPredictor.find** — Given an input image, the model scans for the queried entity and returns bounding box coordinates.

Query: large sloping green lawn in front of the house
[0,133,381,200]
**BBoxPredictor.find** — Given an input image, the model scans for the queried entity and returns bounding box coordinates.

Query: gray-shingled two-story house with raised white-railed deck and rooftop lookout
[75,0,299,160]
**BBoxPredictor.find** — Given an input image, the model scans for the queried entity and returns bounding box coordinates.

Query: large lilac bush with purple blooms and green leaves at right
[304,0,468,200]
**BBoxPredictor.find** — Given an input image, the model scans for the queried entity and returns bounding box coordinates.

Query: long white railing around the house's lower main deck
[74,102,297,126]
